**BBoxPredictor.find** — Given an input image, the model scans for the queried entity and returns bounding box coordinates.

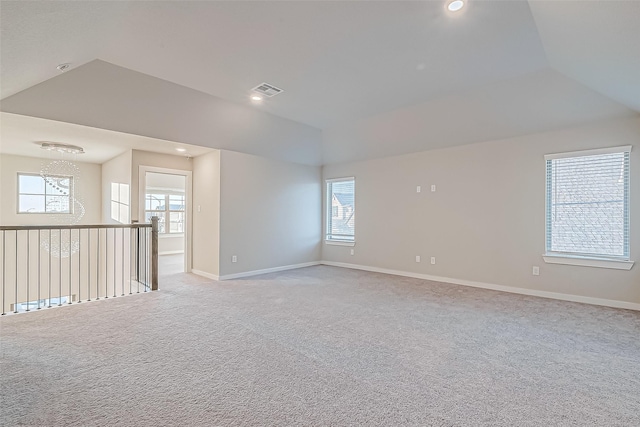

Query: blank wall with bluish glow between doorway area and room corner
[219,151,321,277]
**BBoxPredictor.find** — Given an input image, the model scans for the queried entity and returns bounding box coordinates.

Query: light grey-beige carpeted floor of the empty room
[0,266,640,426]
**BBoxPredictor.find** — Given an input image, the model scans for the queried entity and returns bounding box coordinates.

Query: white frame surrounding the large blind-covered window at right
[543,145,634,270]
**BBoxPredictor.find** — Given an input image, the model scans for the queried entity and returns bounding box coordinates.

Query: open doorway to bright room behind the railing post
[140,167,191,276]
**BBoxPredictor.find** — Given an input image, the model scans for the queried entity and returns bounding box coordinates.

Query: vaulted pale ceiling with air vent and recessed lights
[0,0,640,165]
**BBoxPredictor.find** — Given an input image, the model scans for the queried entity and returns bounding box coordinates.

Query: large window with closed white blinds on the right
[545,146,631,260]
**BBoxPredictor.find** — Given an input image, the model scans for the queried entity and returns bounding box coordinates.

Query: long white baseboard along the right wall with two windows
[320,261,640,311]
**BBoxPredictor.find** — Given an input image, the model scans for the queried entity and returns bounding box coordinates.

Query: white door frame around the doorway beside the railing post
[138,165,193,273]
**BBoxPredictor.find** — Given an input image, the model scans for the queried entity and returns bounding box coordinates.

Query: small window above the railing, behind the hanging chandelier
[18,173,73,214]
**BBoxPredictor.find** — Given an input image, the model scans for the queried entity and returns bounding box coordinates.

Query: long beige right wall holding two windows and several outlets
[322,118,640,303]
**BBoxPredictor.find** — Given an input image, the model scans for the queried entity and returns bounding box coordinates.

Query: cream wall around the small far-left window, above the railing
[0,154,101,225]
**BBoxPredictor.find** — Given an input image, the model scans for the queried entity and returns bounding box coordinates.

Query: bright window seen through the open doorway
[145,192,185,234]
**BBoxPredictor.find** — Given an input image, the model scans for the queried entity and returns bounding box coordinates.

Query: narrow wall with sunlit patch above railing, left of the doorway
[102,150,132,224]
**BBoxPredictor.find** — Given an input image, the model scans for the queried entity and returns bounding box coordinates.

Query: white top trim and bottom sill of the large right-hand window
[542,145,634,270]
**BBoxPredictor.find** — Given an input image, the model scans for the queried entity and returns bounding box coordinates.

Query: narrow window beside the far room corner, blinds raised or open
[326,178,356,243]
